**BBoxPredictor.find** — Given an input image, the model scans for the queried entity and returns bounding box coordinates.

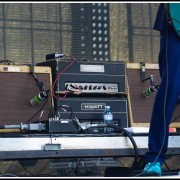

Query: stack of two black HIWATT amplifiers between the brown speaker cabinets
[37,59,128,131]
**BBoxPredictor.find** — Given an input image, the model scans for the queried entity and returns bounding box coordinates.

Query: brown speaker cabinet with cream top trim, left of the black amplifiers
[0,65,53,125]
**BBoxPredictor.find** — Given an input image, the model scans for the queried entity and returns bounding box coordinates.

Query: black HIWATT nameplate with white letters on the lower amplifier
[81,103,106,110]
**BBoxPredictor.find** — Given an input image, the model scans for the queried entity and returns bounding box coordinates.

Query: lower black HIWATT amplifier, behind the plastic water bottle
[55,97,128,128]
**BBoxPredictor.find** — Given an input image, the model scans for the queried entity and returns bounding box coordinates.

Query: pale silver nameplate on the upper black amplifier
[80,64,104,72]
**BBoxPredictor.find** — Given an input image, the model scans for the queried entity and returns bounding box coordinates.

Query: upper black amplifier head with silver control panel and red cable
[36,59,126,95]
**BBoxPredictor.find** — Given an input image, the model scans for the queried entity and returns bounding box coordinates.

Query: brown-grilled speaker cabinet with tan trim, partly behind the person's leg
[126,63,180,128]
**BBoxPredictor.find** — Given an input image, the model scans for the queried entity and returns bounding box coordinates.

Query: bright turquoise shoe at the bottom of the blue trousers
[144,162,161,176]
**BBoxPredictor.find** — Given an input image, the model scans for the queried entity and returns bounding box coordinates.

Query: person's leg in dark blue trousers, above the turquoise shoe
[145,29,180,174]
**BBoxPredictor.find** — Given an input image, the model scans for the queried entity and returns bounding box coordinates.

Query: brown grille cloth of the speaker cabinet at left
[0,72,51,125]
